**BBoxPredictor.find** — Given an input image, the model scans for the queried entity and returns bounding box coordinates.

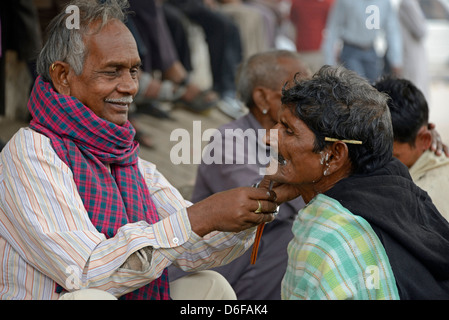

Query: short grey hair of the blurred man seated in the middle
[237,50,311,108]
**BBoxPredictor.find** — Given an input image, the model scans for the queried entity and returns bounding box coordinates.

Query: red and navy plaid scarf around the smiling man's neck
[28,76,170,299]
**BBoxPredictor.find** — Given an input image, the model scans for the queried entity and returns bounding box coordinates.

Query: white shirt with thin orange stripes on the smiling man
[0,128,255,299]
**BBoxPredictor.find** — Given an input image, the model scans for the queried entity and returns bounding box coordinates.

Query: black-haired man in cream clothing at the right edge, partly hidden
[375,77,449,220]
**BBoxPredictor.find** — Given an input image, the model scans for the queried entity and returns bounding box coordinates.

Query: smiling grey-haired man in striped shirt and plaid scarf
[0,1,276,299]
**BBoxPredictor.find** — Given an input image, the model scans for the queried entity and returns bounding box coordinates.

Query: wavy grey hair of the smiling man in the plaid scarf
[36,0,129,82]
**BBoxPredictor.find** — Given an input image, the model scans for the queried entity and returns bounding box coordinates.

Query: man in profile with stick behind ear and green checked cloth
[264,66,449,299]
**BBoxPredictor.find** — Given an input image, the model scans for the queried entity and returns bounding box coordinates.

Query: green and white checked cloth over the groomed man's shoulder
[282,194,399,300]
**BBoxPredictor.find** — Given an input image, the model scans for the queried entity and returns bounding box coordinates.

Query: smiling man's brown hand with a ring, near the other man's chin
[187,187,277,237]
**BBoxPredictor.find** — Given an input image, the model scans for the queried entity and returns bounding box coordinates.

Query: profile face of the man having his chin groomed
[265,106,323,186]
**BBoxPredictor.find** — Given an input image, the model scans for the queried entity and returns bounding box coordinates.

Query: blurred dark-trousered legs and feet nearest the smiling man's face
[128,0,218,112]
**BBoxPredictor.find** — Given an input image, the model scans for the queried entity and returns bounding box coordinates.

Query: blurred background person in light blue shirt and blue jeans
[323,0,402,83]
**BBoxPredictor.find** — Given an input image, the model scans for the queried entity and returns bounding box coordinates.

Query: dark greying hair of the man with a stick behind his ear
[282,66,393,173]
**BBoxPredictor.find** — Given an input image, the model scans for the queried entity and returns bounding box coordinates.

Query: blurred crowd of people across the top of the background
[0,0,435,131]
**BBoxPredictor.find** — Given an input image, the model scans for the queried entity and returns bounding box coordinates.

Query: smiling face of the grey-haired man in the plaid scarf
[67,20,140,125]
